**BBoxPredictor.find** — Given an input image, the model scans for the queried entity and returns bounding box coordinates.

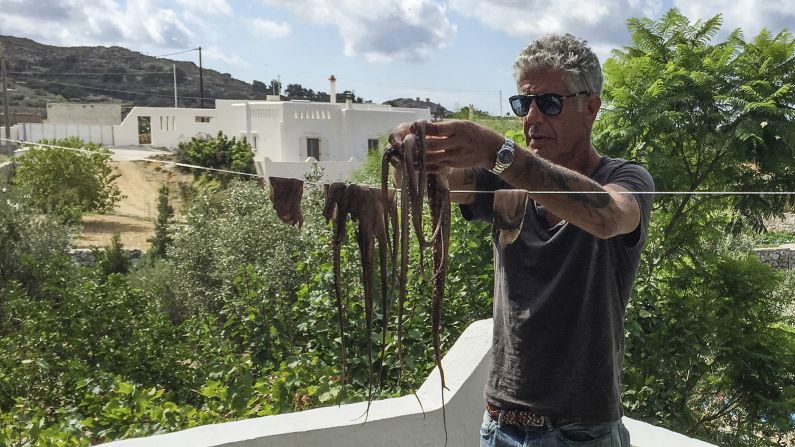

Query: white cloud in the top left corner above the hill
[0,0,196,48]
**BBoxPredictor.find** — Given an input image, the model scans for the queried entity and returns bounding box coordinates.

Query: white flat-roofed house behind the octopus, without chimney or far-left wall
[113,96,431,180]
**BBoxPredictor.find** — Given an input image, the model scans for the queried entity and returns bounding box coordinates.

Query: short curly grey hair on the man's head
[513,34,602,102]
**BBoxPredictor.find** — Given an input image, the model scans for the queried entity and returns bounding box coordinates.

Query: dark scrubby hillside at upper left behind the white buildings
[0,36,265,109]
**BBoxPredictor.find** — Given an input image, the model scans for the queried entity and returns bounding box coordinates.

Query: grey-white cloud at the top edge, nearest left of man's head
[262,0,457,62]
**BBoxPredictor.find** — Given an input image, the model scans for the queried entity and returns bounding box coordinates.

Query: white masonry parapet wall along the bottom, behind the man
[104,319,712,447]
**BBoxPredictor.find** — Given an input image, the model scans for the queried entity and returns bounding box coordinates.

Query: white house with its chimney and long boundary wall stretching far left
[12,76,431,181]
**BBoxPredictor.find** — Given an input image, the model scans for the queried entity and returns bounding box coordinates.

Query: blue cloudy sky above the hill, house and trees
[0,0,795,114]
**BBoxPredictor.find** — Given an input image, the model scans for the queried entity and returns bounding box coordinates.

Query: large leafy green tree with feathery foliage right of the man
[595,9,795,446]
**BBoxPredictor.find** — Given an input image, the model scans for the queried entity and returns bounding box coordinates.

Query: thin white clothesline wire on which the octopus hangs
[6,138,795,196]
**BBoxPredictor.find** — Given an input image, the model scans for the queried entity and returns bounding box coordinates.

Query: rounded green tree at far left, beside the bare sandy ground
[12,137,121,222]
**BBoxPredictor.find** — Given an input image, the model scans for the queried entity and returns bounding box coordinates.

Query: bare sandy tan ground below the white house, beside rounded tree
[75,161,192,251]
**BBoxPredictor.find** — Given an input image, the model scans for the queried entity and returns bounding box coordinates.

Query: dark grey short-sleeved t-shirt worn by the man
[461,157,654,423]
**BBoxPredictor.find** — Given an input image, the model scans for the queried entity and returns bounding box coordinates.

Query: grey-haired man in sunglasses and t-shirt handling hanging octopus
[391,35,654,447]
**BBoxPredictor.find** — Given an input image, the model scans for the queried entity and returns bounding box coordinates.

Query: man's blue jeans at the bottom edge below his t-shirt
[480,413,630,447]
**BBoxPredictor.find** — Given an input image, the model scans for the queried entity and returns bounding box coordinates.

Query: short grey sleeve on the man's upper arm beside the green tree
[608,161,654,247]
